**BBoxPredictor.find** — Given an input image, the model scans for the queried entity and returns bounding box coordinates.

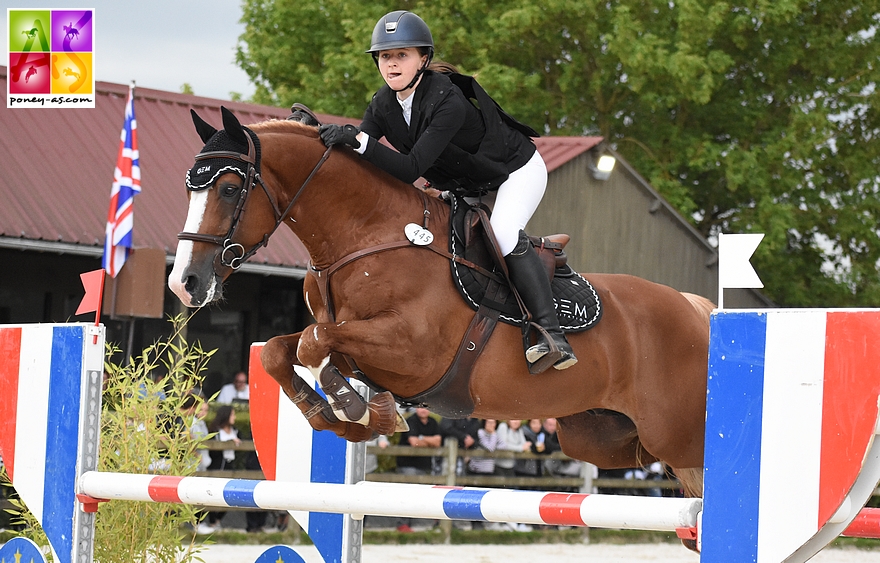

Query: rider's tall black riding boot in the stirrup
[504,231,577,373]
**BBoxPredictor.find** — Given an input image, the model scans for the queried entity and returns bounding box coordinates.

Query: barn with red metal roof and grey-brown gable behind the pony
[0,66,769,393]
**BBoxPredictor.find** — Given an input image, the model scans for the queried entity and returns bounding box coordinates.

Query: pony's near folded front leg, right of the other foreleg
[296,323,406,435]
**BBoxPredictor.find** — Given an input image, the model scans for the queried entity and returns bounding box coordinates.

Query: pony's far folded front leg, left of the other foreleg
[260,333,373,442]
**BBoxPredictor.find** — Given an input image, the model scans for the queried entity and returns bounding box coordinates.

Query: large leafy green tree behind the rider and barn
[238,0,880,307]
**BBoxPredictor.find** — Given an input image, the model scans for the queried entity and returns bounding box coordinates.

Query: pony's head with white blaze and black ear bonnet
[168,108,274,307]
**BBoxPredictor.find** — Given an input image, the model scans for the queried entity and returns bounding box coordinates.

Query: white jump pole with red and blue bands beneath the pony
[79,472,702,532]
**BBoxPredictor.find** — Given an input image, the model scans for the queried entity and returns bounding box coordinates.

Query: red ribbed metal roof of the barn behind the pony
[0,66,601,268]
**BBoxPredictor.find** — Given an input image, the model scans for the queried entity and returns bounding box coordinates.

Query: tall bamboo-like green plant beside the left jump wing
[95,317,214,563]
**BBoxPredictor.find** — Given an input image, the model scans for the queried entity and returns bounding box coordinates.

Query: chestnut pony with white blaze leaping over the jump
[169,108,712,496]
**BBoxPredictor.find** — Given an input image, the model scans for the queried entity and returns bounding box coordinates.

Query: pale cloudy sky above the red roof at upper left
[0,0,254,100]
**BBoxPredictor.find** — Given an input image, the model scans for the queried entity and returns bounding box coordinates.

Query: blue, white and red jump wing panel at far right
[701,309,880,563]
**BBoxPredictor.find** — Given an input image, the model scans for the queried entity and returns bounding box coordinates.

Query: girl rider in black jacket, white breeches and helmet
[320,10,577,373]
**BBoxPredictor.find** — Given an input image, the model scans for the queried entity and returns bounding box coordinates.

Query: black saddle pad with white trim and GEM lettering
[449,197,602,332]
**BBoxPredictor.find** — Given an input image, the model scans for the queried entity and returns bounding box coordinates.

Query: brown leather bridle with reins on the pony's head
[177,130,332,272]
